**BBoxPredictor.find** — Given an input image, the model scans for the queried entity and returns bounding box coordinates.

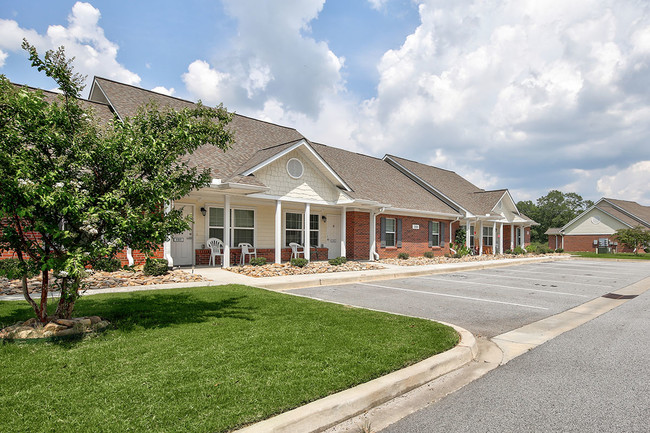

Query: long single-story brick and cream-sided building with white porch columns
[5,77,536,267]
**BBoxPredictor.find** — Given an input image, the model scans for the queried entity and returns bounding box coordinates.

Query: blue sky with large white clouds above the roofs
[0,0,650,204]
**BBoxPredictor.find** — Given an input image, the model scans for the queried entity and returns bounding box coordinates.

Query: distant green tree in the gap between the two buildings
[517,190,594,243]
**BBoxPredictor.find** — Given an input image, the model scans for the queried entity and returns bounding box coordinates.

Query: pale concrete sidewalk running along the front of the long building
[0,256,570,301]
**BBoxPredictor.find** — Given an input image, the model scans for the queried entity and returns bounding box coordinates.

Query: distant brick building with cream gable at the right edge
[545,197,650,252]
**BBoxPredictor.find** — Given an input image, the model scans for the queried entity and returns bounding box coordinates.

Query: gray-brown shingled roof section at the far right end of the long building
[387,155,507,215]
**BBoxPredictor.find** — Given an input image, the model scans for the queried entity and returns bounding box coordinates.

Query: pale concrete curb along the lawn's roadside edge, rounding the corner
[237,324,478,433]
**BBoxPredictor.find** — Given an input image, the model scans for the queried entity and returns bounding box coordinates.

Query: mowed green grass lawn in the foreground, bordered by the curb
[0,285,458,432]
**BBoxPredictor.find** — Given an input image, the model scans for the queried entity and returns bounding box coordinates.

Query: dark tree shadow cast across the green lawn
[0,293,255,331]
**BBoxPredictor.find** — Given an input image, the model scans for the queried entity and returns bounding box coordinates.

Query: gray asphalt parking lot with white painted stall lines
[291,260,650,338]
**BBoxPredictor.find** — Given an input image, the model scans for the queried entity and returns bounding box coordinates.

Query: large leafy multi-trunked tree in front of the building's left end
[0,41,232,322]
